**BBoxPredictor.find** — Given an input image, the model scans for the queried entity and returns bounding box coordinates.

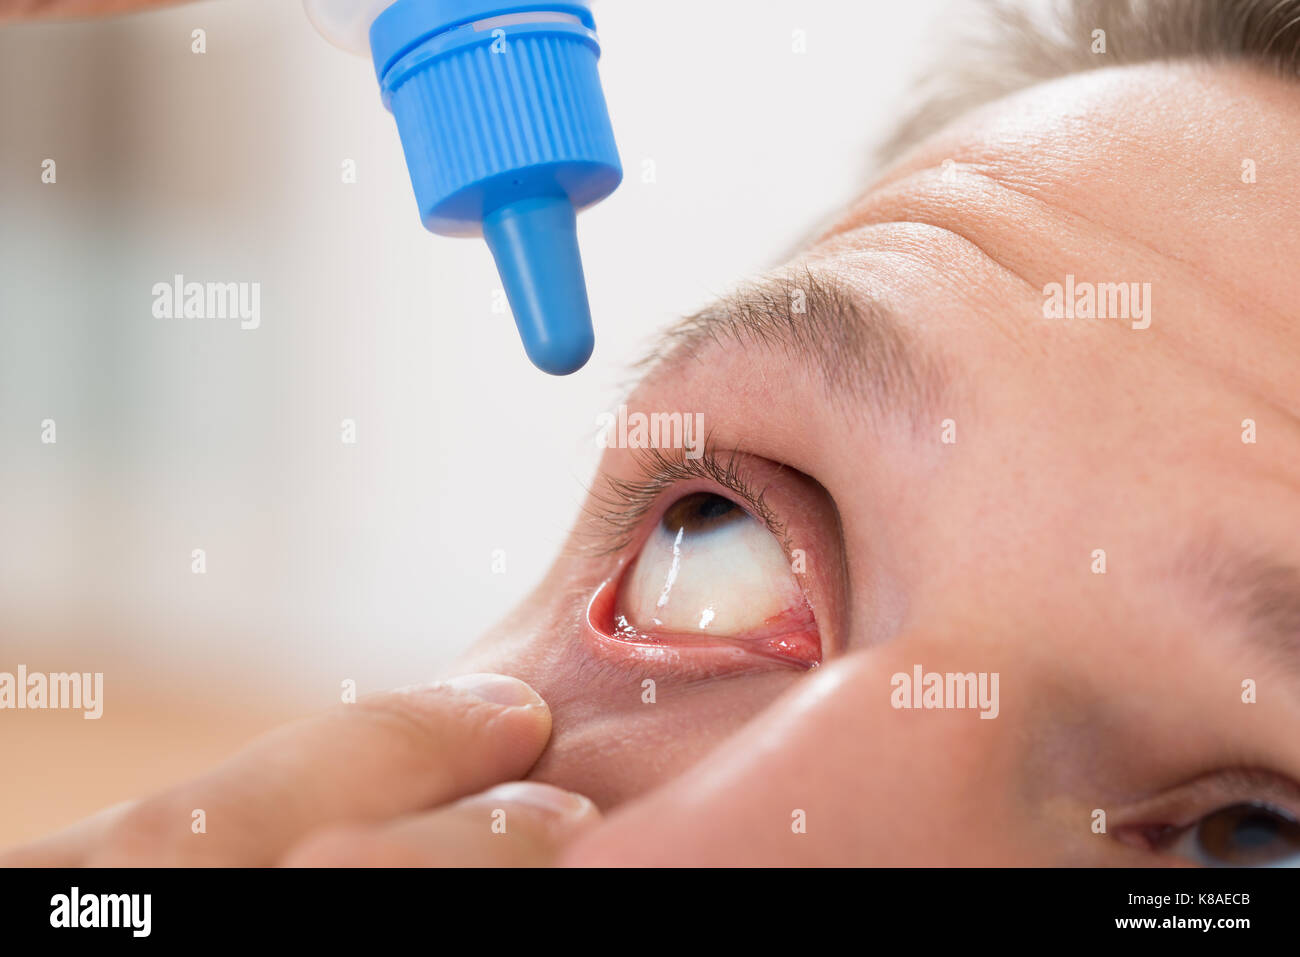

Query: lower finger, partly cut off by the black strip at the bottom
[283,781,601,867]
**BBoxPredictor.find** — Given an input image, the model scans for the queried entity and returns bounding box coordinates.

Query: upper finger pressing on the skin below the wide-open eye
[71,675,551,866]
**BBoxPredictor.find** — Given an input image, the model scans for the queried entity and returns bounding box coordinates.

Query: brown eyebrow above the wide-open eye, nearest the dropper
[634,265,949,424]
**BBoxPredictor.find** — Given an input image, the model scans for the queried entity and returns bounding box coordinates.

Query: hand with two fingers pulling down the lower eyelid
[0,675,599,867]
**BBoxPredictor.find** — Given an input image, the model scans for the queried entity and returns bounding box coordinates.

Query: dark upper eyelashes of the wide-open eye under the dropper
[584,442,789,557]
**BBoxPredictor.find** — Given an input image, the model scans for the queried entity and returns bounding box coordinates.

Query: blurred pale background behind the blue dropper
[0,0,950,843]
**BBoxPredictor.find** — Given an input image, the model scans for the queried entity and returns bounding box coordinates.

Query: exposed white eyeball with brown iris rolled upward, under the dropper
[615,492,811,637]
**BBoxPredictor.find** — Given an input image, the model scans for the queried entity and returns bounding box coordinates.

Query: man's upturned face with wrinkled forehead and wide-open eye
[449,65,1300,863]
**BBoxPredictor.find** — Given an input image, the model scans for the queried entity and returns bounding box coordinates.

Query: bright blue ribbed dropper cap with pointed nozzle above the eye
[371,0,623,376]
